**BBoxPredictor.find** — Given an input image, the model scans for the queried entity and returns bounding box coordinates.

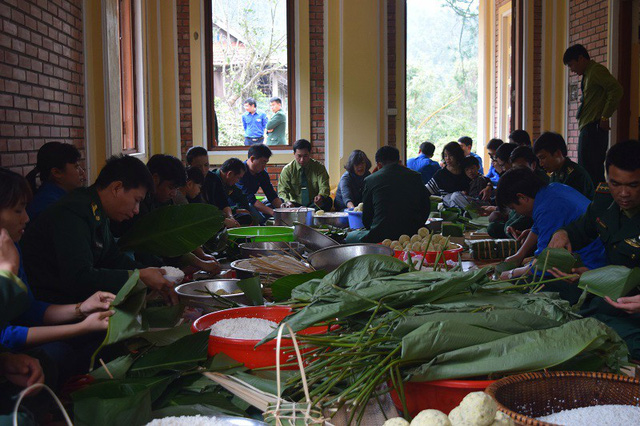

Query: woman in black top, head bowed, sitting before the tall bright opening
[427,142,471,207]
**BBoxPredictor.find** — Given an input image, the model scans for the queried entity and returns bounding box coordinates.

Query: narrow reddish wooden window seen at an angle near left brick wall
[118,0,138,154]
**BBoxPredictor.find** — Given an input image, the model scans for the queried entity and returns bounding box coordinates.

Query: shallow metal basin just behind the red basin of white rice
[176,278,258,312]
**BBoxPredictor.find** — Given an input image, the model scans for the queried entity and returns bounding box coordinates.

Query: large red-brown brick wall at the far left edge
[0,0,85,174]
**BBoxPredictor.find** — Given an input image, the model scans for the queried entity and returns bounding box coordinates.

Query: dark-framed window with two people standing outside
[205,0,295,150]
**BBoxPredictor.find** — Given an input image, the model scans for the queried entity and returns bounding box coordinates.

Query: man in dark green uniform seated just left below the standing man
[533,132,594,200]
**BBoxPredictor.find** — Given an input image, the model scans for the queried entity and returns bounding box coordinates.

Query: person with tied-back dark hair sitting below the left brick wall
[27,142,85,220]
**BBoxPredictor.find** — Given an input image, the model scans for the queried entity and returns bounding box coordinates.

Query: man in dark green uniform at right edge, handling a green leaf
[549,141,640,359]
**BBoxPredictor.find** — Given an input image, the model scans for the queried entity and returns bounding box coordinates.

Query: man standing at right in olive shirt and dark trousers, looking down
[562,44,622,186]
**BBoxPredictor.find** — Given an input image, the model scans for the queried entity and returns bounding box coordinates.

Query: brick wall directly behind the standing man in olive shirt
[567,0,608,160]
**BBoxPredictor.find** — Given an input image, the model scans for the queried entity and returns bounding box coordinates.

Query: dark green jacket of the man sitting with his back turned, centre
[362,164,431,243]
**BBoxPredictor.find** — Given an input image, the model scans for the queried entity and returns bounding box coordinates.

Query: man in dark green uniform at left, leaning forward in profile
[22,155,177,304]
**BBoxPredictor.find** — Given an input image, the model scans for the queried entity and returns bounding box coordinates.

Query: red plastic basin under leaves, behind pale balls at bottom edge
[391,380,495,417]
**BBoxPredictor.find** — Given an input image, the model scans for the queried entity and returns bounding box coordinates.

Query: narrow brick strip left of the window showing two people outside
[176,0,193,161]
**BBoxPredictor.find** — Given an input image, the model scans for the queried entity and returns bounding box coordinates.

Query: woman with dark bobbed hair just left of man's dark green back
[335,149,371,211]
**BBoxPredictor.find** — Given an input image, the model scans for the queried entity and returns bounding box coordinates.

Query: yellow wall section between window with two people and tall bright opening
[325,0,386,181]
